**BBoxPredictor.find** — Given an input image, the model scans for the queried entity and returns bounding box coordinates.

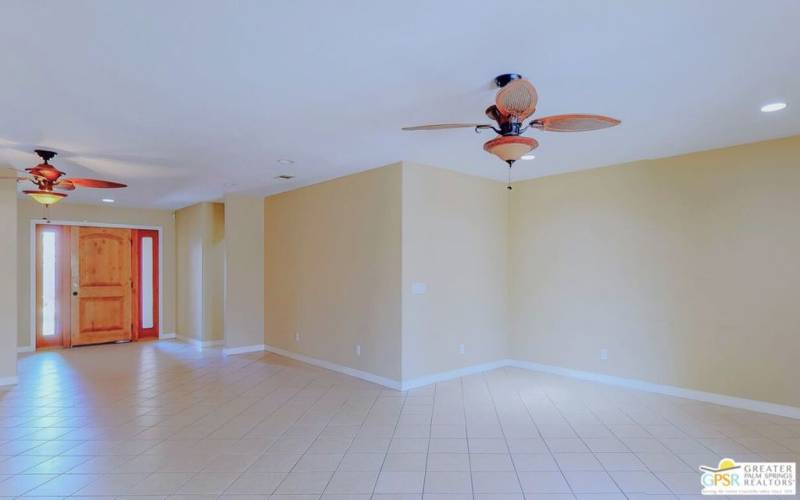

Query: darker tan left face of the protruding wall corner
[264,164,402,380]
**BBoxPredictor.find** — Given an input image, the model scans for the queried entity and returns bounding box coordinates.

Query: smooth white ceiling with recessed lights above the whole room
[0,0,800,208]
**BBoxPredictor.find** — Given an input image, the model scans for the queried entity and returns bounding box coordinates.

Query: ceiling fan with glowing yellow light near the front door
[3,149,128,205]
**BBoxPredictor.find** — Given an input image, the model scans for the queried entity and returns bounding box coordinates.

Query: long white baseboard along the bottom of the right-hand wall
[509,360,800,419]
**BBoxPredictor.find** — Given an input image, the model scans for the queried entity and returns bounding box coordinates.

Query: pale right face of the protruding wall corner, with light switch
[403,163,508,380]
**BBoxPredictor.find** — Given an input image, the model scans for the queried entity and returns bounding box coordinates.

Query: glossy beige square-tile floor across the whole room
[0,341,800,500]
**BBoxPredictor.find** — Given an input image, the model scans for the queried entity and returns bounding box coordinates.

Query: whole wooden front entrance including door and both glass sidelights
[32,222,160,349]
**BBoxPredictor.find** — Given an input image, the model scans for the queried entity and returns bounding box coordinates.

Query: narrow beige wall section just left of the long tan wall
[225,195,264,348]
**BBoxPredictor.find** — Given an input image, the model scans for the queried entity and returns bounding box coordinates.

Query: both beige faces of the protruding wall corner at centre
[264,163,508,381]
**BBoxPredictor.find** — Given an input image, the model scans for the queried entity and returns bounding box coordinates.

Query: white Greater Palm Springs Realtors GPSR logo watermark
[700,458,797,495]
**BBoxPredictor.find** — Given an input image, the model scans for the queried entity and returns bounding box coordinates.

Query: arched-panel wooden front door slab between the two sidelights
[70,226,132,345]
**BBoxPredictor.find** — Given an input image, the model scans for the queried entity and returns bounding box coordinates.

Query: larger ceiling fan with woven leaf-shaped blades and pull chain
[403,73,621,189]
